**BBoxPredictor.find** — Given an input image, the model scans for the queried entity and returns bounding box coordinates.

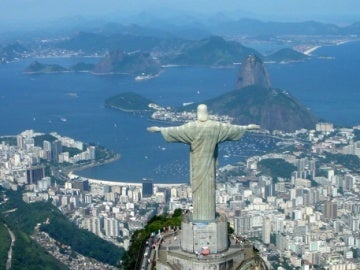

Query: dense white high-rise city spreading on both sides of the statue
[0,123,360,269]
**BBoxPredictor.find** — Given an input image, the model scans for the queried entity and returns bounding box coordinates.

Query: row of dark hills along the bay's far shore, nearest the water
[25,35,309,76]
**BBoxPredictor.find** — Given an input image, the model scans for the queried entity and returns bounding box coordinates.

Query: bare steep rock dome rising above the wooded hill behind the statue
[235,54,271,89]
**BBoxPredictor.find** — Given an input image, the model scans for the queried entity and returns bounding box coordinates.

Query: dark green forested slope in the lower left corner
[0,191,124,269]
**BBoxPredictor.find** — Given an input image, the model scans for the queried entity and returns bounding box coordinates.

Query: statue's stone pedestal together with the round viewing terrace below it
[156,213,252,270]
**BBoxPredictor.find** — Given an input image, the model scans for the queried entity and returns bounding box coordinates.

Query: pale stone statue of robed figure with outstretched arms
[147,104,259,222]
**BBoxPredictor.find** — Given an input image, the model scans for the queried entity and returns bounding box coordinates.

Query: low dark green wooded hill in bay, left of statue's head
[105,92,153,112]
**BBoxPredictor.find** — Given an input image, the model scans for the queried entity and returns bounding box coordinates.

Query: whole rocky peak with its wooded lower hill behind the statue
[200,55,317,132]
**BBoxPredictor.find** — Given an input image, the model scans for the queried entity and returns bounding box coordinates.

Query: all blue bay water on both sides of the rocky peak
[0,42,360,183]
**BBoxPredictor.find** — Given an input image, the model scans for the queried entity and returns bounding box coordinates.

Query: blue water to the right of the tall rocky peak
[268,41,360,126]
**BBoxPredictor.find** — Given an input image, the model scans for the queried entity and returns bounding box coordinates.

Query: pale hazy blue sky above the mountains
[0,0,360,22]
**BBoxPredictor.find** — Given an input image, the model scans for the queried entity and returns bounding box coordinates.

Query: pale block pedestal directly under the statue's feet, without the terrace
[181,214,229,254]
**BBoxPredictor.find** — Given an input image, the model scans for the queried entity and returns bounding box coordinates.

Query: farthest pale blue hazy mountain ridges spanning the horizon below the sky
[3,14,360,39]
